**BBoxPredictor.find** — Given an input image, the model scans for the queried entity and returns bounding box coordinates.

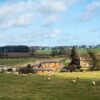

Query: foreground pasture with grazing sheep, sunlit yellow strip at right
[0,72,100,100]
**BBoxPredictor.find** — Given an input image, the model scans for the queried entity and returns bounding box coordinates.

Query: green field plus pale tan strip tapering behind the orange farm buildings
[0,58,65,67]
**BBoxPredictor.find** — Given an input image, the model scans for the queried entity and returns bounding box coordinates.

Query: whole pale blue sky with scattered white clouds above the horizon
[0,0,100,46]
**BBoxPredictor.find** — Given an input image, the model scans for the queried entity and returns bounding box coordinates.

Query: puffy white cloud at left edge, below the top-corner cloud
[0,13,34,28]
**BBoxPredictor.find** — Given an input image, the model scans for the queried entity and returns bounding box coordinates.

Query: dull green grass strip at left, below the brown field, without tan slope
[0,58,36,66]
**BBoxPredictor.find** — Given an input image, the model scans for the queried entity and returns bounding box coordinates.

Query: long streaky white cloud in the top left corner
[0,0,33,16]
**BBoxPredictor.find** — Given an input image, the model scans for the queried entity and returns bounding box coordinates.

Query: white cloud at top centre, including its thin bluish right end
[39,0,78,14]
